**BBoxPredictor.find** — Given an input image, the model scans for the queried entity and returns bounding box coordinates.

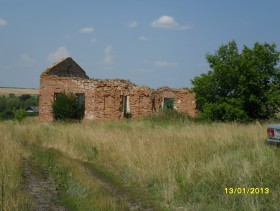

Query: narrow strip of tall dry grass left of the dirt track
[0,123,30,211]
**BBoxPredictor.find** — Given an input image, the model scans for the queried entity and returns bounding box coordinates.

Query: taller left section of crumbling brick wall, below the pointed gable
[39,74,135,122]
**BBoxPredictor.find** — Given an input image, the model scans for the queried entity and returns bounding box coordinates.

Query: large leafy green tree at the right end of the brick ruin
[192,41,280,121]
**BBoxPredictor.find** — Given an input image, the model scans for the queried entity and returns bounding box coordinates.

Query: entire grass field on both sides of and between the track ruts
[0,114,280,210]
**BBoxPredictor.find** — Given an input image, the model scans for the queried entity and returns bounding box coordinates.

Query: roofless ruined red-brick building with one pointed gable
[39,58,196,122]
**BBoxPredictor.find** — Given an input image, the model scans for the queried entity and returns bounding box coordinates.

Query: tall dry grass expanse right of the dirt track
[3,120,280,210]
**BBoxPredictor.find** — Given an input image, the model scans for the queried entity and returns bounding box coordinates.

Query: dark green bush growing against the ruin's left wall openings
[52,93,85,121]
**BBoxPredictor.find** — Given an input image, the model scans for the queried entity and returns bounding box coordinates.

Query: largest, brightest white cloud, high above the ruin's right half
[151,15,192,30]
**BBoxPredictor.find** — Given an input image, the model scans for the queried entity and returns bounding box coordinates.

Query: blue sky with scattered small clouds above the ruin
[0,0,280,88]
